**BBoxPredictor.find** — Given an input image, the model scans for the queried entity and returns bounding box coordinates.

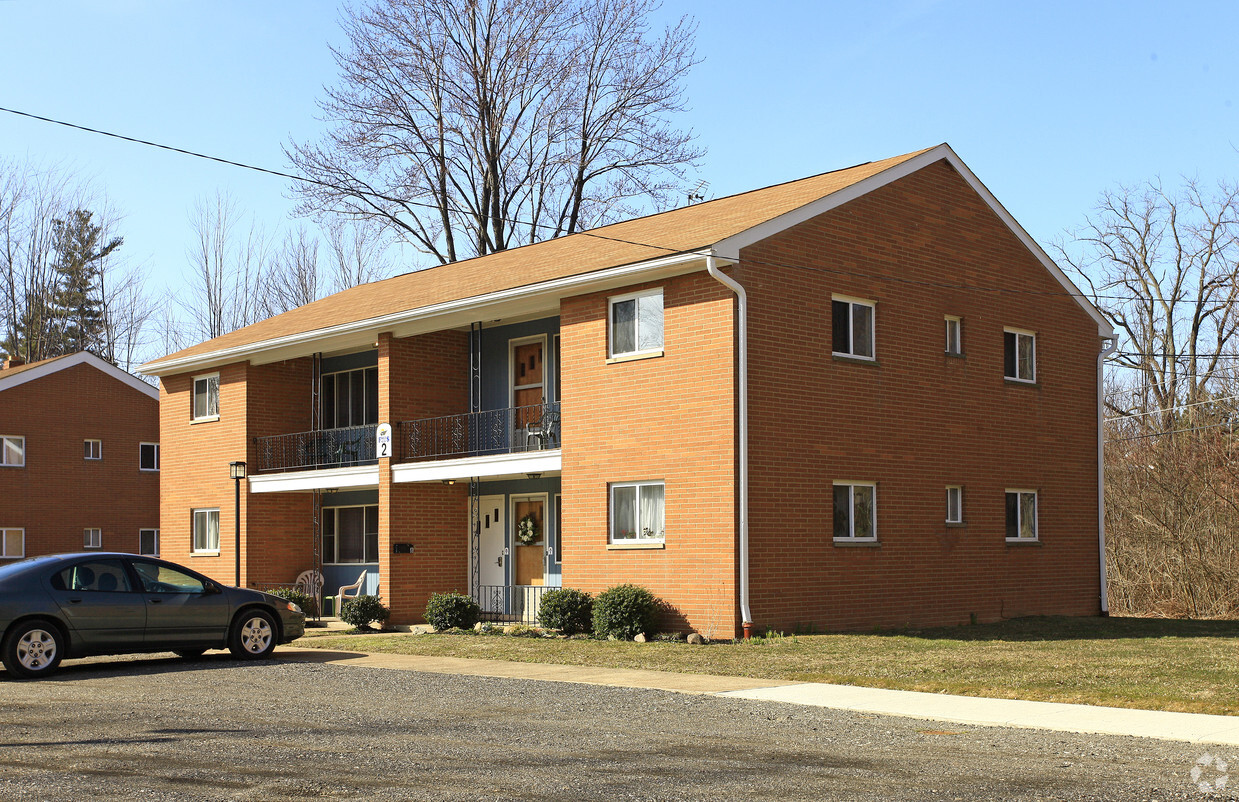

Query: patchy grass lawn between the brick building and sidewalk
[296,617,1239,715]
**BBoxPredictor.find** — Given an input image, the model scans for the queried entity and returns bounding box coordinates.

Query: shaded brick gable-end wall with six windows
[737,162,1099,630]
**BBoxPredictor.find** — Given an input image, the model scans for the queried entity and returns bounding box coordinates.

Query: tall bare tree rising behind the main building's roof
[286,0,701,263]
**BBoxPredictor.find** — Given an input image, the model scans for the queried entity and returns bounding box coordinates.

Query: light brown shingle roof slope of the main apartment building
[152,150,924,364]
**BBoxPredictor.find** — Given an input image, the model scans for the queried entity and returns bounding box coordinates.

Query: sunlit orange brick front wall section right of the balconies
[560,273,736,636]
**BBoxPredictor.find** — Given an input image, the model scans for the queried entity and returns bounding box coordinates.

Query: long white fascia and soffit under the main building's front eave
[141,252,705,376]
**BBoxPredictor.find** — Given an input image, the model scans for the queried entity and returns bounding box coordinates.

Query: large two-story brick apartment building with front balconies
[144,145,1113,635]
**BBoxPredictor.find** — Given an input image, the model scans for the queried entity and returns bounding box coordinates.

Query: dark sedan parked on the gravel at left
[0,552,305,677]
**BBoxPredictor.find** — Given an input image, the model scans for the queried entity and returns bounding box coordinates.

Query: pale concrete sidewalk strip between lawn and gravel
[276,646,1239,746]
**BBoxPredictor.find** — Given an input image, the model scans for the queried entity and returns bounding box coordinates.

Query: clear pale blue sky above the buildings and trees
[0,0,1239,342]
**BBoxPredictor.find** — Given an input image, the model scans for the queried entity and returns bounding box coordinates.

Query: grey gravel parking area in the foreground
[0,653,1239,802]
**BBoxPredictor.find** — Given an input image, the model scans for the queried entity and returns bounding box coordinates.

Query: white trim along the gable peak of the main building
[715,143,1114,337]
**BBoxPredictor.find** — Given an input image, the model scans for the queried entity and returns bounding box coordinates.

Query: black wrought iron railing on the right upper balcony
[399,402,560,462]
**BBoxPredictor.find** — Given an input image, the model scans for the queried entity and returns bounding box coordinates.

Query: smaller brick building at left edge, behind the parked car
[0,352,160,562]
